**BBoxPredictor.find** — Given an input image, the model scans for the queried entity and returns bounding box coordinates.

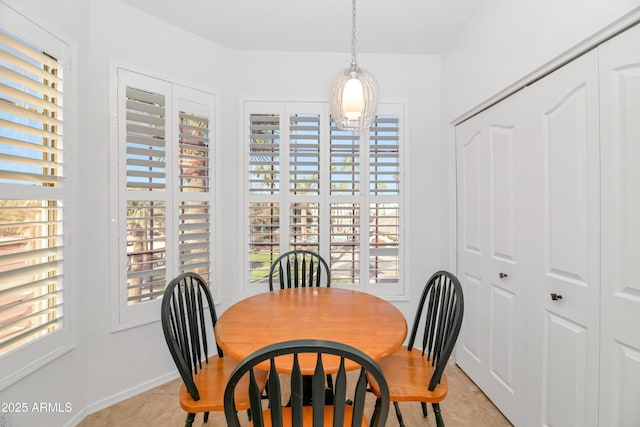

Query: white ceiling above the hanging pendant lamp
[122,0,482,54]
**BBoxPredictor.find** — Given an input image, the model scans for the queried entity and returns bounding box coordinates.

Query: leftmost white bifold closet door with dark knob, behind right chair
[456,89,527,424]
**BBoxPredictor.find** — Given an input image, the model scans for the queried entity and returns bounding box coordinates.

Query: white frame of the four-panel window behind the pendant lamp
[239,99,408,300]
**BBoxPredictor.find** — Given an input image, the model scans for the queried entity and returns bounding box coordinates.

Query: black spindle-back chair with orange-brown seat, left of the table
[161,273,267,427]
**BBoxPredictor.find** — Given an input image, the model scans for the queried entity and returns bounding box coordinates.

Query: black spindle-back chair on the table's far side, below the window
[269,249,331,291]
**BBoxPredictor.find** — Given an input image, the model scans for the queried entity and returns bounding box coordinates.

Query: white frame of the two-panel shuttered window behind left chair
[110,65,219,332]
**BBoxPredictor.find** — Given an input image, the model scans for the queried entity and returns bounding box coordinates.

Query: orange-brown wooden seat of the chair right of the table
[369,346,448,403]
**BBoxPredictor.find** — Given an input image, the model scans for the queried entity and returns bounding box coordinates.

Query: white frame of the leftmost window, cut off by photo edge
[0,3,78,390]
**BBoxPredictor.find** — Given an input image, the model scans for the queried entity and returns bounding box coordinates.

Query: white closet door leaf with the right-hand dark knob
[522,51,600,427]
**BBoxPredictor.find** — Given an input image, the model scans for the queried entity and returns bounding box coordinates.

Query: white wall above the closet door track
[442,0,640,121]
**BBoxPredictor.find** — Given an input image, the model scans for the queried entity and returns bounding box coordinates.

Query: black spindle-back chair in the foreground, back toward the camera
[224,340,390,427]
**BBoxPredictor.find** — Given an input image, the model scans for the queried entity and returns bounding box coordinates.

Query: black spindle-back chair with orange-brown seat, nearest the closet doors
[371,271,464,427]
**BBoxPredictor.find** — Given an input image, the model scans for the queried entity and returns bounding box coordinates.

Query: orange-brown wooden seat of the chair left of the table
[180,355,267,413]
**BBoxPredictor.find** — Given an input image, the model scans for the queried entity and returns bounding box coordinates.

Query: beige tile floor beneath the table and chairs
[78,365,511,427]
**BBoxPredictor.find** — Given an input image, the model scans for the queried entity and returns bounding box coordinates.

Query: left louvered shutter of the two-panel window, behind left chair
[121,79,170,305]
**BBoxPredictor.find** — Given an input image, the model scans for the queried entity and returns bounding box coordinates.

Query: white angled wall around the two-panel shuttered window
[80,0,229,418]
